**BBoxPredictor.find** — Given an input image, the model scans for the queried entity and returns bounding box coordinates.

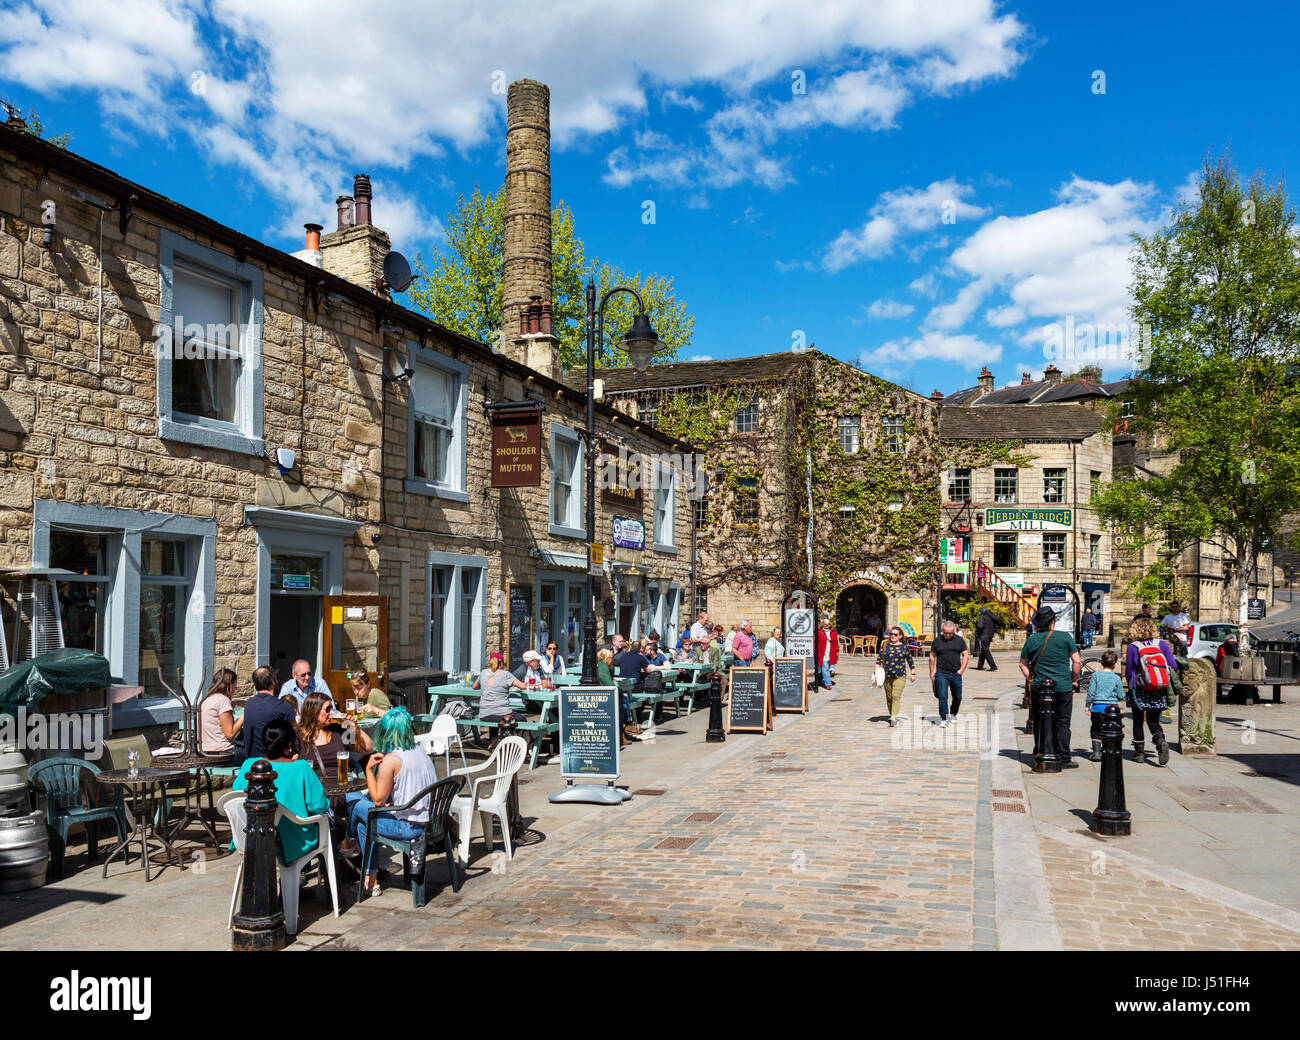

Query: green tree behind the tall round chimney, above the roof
[410,185,696,368]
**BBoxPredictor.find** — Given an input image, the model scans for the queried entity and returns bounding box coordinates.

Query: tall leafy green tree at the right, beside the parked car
[1099,155,1300,625]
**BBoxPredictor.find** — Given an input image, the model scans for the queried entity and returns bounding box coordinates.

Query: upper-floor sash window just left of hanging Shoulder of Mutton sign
[406,347,469,502]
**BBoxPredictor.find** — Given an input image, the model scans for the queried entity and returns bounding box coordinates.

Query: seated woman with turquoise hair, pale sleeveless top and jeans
[341,707,438,896]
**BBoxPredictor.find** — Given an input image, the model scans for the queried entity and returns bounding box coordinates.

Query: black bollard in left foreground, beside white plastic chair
[230,759,285,950]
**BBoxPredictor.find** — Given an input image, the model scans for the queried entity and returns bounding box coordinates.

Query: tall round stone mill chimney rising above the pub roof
[501,79,560,378]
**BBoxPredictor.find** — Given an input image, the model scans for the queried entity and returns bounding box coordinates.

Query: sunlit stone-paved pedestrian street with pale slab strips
[0,658,1300,950]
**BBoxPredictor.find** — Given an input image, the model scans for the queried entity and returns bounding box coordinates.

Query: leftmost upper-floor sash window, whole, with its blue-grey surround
[156,230,264,455]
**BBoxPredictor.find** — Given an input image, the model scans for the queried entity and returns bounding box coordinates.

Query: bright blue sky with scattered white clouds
[0,0,1300,394]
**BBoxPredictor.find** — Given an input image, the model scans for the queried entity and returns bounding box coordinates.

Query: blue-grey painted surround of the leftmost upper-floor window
[155,228,267,455]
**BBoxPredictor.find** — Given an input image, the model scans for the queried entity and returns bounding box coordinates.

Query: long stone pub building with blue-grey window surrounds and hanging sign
[0,85,692,724]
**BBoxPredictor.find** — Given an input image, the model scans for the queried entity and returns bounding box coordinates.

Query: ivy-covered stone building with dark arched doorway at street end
[585,350,940,634]
